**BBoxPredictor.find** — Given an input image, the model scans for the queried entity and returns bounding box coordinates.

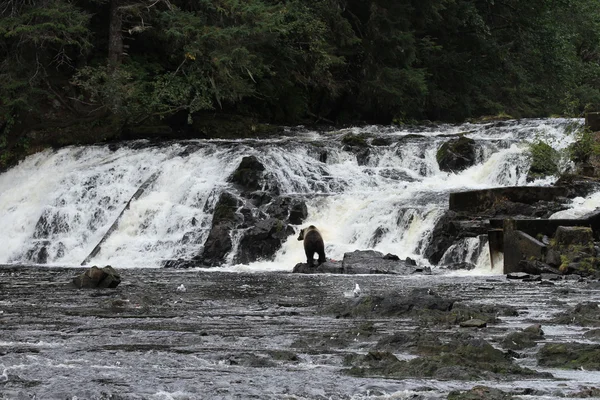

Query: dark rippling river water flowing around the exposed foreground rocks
[0,266,600,399]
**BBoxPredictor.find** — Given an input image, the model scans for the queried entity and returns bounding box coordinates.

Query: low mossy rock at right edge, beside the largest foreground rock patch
[537,343,600,371]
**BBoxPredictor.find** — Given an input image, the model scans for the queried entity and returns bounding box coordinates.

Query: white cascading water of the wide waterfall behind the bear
[0,119,581,270]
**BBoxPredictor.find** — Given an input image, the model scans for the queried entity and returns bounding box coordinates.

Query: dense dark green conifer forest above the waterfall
[0,0,600,168]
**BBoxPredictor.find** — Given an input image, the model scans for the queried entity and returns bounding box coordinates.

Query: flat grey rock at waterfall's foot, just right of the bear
[342,250,414,275]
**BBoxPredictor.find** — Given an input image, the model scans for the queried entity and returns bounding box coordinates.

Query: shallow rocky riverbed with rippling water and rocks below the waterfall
[0,266,600,399]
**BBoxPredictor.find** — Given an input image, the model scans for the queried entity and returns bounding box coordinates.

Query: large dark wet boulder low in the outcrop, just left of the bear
[236,218,294,264]
